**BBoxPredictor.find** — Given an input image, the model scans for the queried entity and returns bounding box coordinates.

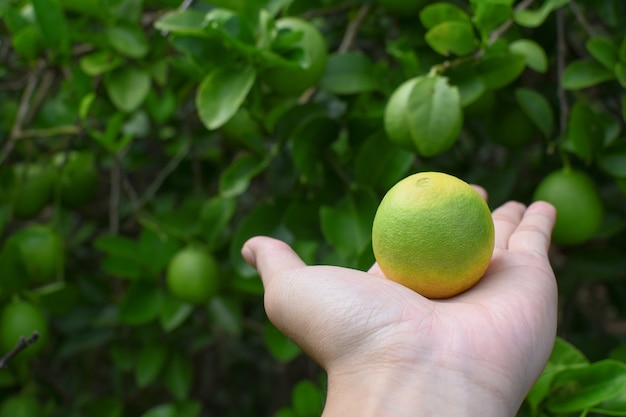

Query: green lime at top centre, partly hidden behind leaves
[263,17,328,95]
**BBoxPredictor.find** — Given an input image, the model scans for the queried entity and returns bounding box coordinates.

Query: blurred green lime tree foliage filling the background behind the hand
[0,0,626,417]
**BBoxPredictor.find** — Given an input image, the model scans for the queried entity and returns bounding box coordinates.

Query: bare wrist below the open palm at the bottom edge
[322,358,519,417]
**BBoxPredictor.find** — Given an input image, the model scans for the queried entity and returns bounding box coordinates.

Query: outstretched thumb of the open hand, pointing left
[241,236,305,287]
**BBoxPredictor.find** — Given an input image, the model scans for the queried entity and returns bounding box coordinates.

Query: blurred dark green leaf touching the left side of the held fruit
[320,190,378,255]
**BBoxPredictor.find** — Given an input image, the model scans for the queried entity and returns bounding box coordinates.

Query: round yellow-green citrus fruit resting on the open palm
[372,172,495,298]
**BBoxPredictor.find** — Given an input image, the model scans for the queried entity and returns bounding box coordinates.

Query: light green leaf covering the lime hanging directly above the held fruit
[408,76,463,157]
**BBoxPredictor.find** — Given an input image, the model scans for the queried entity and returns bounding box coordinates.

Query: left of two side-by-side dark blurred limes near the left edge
[13,164,56,219]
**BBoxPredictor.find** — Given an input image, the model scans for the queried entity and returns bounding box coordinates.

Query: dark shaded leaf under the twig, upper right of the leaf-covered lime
[476,52,526,90]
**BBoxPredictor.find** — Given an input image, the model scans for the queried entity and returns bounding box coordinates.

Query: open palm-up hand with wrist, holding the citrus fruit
[242,197,557,417]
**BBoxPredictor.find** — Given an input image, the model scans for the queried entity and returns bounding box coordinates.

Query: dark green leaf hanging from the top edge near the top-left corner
[31,0,69,54]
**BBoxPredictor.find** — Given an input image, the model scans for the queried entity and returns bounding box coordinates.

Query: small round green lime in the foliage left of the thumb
[166,247,219,304]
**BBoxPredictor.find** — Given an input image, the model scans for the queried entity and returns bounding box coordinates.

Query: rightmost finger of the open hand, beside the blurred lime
[509,201,556,255]
